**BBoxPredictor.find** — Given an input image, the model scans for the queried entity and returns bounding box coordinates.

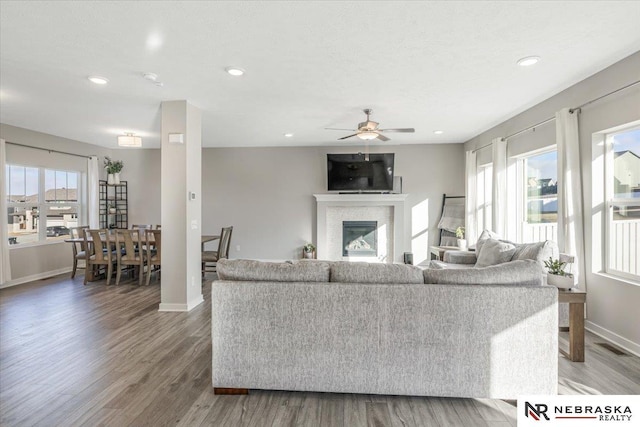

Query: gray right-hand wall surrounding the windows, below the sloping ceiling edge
[465,53,640,353]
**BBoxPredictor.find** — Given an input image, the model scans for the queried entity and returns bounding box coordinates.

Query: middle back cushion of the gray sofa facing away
[331,261,424,284]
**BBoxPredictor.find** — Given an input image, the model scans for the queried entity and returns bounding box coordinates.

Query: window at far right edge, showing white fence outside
[605,128,640,280]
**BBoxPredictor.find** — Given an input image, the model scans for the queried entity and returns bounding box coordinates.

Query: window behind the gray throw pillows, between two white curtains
[518,149,558,243]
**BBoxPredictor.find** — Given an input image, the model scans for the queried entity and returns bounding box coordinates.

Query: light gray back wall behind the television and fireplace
[202,144,464,263]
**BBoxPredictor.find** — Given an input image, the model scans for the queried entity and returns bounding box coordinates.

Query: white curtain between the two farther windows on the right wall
[491,138,508,237]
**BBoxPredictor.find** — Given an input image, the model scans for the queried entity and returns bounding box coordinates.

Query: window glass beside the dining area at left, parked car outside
[5,165,81,245]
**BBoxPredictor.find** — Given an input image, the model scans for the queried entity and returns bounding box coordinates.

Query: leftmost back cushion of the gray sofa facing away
[216,259,330,282]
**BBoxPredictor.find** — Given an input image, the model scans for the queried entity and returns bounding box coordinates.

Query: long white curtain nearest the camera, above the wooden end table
[556,108,585,283]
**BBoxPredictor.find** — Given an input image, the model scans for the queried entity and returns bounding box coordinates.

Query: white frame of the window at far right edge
[602,124,640,283]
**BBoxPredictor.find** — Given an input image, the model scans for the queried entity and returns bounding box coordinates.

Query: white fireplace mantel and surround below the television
[314,193,409,262]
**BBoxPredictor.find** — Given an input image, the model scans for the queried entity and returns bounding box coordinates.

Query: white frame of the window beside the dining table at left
[2,163,86,250]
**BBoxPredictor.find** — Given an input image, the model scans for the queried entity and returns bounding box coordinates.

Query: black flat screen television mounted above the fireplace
[327,153,395,192]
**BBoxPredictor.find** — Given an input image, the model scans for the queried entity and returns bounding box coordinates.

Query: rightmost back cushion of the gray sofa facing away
[424,260,543,286]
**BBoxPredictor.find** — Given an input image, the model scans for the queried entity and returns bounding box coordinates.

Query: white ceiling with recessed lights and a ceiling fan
[0,1,640,148]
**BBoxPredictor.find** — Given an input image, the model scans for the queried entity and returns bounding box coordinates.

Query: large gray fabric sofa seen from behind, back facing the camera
[211,260,558,399]
